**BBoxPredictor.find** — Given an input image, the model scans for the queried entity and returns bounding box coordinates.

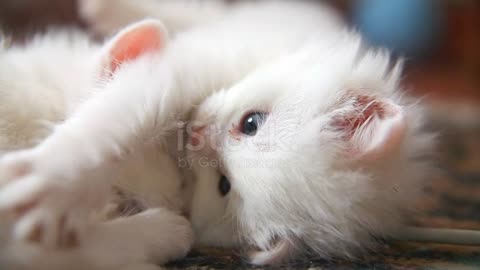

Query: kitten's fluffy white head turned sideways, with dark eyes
[187,35,432,263]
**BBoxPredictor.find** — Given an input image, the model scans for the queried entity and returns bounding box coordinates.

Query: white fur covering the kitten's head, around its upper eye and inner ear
[188,36,432,263]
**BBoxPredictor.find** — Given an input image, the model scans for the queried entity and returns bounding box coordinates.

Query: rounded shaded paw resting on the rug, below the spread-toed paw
[81,208,194,269]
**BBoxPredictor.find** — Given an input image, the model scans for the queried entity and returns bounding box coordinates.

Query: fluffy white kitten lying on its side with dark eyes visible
[0,1,431,268]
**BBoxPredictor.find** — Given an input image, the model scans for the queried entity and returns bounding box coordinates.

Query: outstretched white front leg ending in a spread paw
[0,75,171,247]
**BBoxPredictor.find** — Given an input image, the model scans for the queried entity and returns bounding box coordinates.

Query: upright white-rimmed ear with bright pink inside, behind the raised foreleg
[101,19,168,74]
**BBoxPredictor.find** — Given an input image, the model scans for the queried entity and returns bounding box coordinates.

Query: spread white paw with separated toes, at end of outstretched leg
[0,150,104,249]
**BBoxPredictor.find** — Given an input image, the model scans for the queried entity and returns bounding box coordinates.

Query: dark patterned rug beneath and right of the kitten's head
[168,128,480,270]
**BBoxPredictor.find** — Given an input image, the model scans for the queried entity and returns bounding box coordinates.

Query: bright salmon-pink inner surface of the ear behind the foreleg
[109,25,164,72]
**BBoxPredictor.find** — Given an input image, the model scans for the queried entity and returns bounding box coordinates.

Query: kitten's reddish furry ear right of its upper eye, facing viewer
[333,95,407,160]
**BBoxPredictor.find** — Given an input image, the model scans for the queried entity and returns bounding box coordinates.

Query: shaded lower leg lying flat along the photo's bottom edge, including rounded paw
[0,208,193,270]
